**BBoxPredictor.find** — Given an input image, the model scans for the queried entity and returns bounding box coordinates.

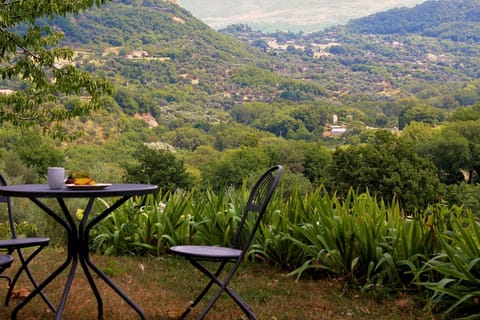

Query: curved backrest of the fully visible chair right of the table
[233,165,282,254]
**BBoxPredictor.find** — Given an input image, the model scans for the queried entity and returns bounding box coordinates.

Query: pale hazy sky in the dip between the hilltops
[179,0,425,32]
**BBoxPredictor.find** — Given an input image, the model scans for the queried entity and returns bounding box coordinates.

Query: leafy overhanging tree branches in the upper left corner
[0,0,112,134]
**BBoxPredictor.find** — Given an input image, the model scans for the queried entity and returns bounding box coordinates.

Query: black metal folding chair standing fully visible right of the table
[170,165,282,319]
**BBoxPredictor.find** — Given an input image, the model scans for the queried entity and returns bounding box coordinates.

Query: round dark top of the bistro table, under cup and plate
[0,183,158,198]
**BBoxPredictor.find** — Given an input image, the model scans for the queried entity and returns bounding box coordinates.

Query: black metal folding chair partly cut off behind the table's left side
[0,175,55,311]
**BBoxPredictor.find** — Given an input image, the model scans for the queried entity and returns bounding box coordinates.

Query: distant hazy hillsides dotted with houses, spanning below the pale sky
[23,0,480,138]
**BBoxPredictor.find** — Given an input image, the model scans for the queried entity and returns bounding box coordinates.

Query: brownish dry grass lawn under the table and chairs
[0,248,433,320]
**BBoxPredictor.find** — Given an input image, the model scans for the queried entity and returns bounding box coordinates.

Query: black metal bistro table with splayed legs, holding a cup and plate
[0,184,158,319]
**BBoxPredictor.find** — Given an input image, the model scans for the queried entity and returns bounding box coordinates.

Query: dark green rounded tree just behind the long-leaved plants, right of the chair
[329,130,442,212]
